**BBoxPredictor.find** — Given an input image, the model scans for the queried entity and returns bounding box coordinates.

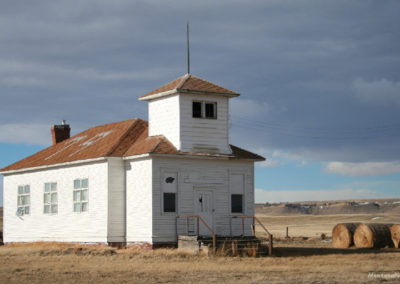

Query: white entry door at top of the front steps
[194,189,214,236]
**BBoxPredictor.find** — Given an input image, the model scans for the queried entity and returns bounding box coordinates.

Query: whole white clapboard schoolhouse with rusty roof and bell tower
[0,74,264,246]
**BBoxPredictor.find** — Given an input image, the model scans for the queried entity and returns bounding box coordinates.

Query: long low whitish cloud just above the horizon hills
[255,189,391,203]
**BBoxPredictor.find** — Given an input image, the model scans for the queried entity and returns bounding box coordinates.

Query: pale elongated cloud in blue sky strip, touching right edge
[324,161,400,177]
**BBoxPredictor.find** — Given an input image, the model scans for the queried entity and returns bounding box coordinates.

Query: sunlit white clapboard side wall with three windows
[3,162,108,243]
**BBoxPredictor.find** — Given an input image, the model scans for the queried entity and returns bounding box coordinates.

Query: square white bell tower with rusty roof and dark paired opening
[139,74,239,154]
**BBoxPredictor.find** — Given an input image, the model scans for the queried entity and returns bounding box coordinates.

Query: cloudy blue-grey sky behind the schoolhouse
[0,0,400,203]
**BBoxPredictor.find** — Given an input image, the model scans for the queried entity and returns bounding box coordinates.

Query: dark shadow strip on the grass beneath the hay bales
[273,247,400,257]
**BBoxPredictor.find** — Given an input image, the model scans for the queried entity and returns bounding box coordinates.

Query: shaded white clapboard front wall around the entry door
[152,157,254,242]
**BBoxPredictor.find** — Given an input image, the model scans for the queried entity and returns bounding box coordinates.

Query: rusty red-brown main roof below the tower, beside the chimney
[0,118,265,172]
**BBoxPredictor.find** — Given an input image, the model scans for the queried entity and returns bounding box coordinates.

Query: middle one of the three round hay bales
[354,224,393,248]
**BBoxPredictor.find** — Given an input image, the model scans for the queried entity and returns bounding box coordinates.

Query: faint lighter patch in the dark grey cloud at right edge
[353,78,400,106]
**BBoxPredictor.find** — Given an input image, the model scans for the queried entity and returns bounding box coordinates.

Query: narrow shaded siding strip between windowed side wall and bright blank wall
[108,157,126,242]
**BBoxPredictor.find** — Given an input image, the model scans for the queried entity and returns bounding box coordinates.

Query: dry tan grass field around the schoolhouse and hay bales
[0,211,400,283]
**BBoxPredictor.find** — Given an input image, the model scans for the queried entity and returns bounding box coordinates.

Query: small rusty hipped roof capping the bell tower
[139,74,239,100]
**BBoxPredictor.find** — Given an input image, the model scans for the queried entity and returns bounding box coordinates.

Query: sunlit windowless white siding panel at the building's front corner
[126,158,153,243]
